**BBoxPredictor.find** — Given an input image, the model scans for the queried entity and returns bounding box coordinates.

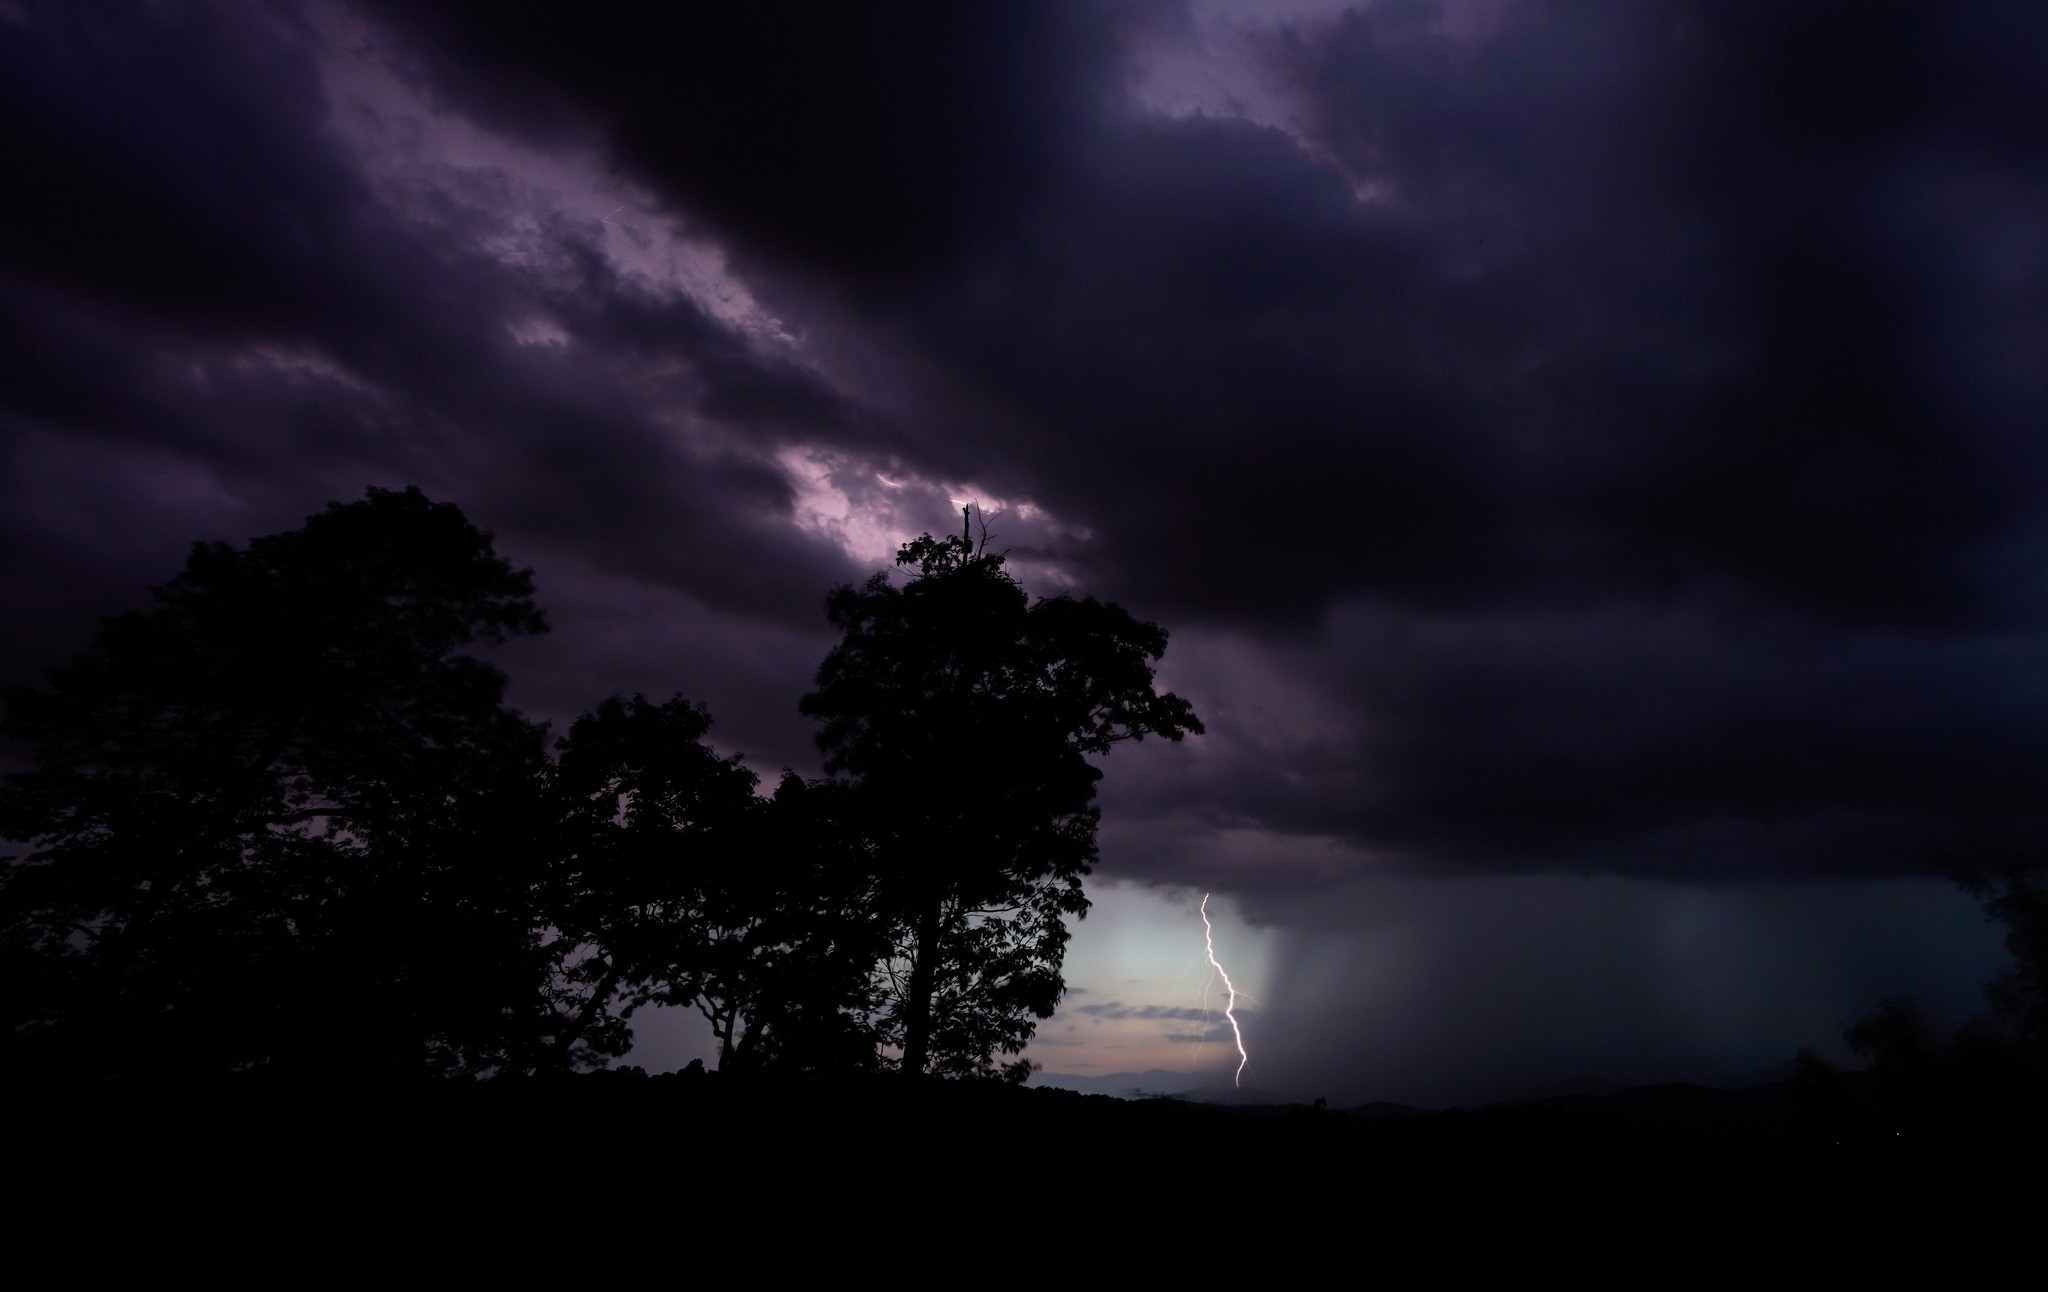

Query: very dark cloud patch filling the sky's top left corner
[0,4,367,334]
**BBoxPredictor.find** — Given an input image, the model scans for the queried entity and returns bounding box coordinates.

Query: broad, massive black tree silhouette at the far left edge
[0,489,547,1073]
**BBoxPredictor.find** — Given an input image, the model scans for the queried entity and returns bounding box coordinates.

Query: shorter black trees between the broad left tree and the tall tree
[543,696,877,1071]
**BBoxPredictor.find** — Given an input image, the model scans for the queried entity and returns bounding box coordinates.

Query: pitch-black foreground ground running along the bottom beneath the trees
[8,1071,2048,1286]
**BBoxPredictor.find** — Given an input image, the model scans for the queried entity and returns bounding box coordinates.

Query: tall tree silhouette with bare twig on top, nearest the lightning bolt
[801,534,1202,1081]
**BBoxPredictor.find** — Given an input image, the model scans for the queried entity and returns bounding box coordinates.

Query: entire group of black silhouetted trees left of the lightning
[0,489,1202,1079]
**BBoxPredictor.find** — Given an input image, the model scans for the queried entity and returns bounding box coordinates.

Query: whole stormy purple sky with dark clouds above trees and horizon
[0,0,2048,1102]
